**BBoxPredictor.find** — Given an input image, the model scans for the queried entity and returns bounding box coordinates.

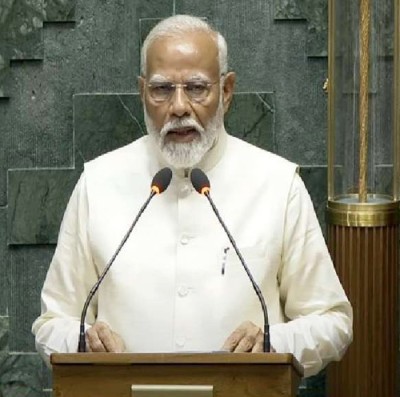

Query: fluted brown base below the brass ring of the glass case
[328,225,399,397]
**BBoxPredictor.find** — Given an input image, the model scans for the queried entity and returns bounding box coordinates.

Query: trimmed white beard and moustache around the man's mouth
[144,100,224,169]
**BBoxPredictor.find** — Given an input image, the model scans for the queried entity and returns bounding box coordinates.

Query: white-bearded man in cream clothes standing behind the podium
[33,16,352,376]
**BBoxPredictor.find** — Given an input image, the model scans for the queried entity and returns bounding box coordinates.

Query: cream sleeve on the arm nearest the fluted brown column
[271,174,352,376]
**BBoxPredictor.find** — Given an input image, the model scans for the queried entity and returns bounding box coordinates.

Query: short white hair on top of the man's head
[140,15,228,76]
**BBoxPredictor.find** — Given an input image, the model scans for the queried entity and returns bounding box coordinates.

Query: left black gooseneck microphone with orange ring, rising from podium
[78,167,172,353]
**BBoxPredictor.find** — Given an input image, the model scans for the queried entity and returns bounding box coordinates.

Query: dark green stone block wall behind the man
[0,0,327,397]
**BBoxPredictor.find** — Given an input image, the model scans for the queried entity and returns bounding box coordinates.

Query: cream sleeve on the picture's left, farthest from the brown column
[32,174,98,363]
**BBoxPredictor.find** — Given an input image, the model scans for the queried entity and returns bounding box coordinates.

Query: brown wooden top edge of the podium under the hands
[50,352,304,376]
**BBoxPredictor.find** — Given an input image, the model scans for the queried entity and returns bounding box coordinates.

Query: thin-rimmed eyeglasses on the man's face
[147,80,219,102]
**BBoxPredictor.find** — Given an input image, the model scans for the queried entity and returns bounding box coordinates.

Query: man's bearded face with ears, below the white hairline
[140,31,234,168]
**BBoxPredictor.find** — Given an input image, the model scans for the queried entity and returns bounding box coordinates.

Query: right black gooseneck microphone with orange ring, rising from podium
[190,168,271,353]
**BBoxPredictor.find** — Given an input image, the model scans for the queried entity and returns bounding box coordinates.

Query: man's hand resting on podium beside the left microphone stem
[86,321,125,353]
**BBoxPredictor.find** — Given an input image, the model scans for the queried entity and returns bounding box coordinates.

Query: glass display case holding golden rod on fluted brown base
[327,0,400,397]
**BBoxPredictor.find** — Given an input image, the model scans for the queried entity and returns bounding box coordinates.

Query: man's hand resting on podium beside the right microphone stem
[222,321,264,353]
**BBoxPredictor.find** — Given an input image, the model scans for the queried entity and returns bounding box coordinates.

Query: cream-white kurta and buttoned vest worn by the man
[33,131,352,376]
